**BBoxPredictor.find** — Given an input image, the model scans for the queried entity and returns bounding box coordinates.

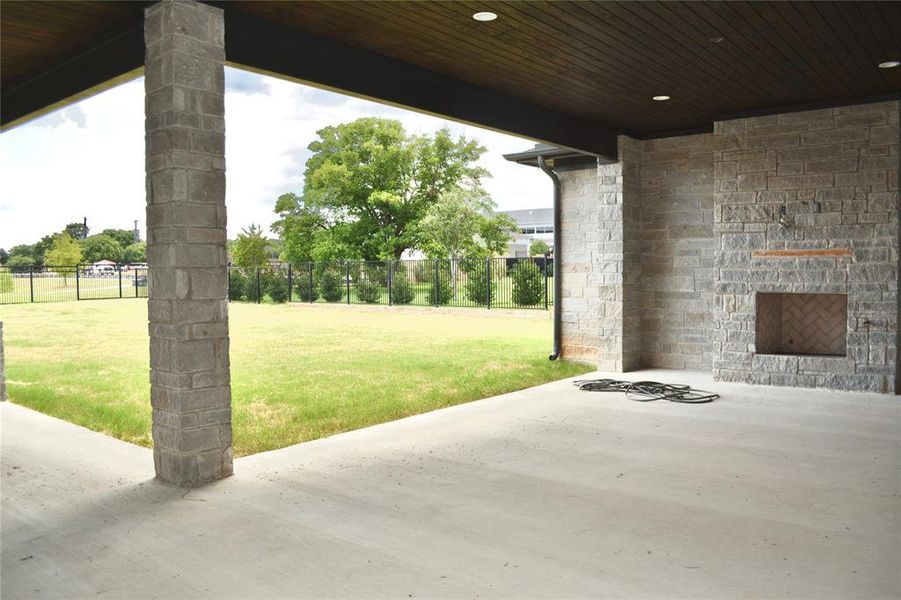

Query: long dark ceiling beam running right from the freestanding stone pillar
[220,7,617,158]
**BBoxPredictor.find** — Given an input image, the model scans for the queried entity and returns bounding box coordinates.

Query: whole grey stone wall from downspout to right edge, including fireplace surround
[560,101,901,392]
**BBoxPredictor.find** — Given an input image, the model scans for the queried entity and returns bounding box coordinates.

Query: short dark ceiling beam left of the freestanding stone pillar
[0,20,144,131]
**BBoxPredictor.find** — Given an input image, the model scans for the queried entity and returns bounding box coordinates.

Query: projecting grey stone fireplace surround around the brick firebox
[712,101,899,392]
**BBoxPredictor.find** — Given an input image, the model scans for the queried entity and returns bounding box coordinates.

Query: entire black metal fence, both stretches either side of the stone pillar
[0,256,554,310]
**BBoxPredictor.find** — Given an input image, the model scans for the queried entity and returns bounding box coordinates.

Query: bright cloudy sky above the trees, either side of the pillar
[0,67,552,249]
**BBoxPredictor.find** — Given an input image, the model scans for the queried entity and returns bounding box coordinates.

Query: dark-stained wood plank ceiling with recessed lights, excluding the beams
[0,0,901,137]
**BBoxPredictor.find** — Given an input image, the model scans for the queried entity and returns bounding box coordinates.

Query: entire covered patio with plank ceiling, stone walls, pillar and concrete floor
[0,0,901,598]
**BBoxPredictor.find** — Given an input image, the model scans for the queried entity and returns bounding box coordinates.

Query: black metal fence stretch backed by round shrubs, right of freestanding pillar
[228,256,554,310]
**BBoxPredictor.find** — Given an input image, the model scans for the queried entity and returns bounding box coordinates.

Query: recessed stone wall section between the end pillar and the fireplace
[639,133,716,370]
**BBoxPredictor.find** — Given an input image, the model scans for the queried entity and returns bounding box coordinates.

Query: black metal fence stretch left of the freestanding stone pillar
[0,265,147,304]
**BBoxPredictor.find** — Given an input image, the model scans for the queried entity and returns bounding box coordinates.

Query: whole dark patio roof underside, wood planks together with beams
[0,0,901,162]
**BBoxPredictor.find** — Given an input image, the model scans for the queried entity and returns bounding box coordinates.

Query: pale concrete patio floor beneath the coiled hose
[0,371,901,599]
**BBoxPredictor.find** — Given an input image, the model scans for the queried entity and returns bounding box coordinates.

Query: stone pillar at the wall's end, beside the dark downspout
[560,136,641,372]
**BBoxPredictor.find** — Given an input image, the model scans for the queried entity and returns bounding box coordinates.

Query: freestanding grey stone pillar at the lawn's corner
[144,0,232,486]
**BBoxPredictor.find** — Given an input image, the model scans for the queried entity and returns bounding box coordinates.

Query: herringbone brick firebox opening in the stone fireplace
[756,292,848,356]
